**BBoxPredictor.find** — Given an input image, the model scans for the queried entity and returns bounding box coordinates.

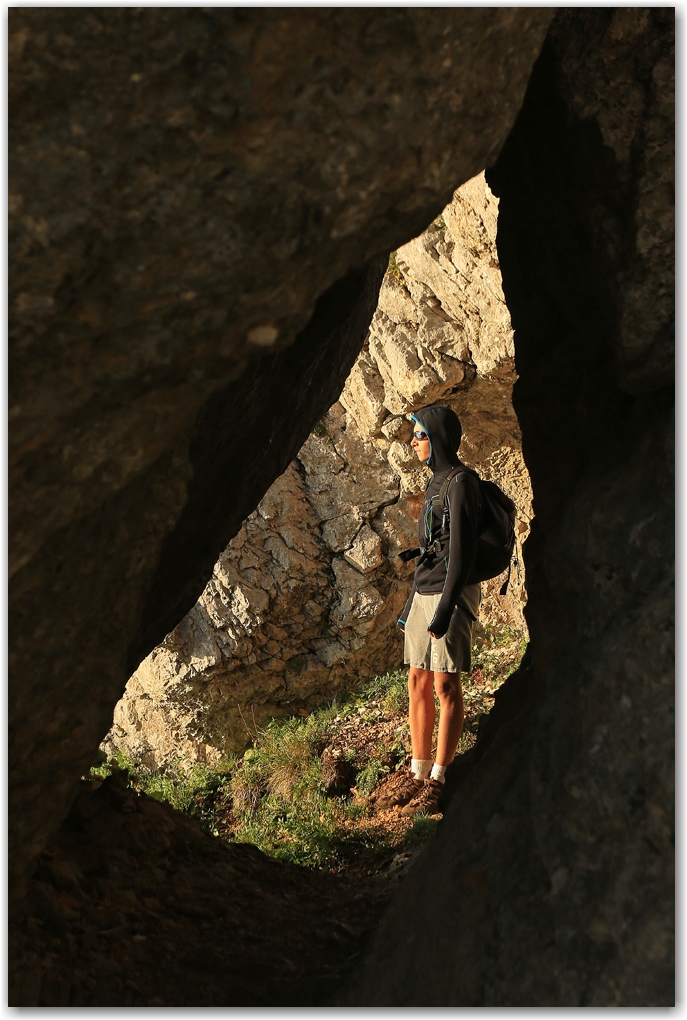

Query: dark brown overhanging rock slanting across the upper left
[9,7,550,891]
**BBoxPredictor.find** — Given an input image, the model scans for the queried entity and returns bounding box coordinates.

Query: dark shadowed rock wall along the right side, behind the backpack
[342,8,675,1007]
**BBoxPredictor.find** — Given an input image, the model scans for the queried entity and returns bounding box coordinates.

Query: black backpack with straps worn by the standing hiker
[400,466,516,595]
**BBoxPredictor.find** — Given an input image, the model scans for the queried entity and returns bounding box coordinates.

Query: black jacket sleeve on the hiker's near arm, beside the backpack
[427,471,480,638]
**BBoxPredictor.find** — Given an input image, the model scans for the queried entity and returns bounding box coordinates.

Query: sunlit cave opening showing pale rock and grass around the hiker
[96,173,532,872]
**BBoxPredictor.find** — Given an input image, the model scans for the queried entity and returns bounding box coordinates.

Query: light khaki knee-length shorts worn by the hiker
[404,584,481,673]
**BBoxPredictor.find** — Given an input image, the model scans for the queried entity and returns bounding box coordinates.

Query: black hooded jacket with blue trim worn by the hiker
[399,406,480,638]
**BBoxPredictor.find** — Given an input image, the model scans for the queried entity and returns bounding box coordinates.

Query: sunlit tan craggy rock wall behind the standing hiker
[104,174,531,767]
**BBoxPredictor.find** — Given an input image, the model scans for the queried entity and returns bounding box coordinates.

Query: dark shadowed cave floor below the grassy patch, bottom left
[9,772,393,1009]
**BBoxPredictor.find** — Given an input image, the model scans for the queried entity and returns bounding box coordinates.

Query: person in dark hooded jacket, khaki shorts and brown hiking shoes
[377,406,481,815]
